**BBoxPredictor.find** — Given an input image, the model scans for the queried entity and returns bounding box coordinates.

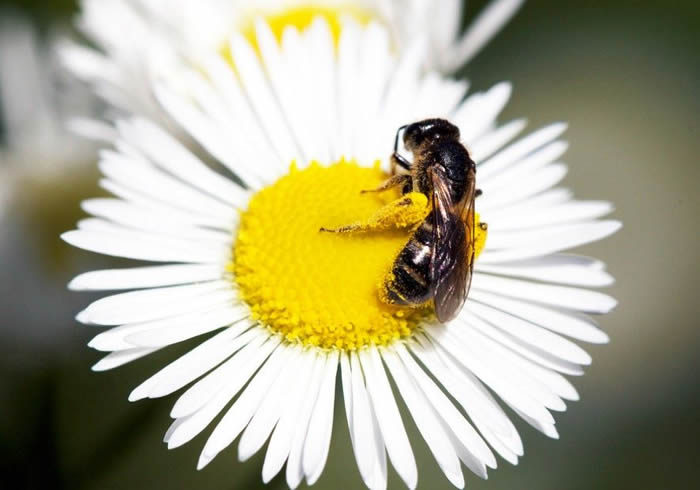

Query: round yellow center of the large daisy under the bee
[232,161,485,350]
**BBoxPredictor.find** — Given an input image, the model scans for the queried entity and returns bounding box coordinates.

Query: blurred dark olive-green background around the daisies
[0,0,700,490]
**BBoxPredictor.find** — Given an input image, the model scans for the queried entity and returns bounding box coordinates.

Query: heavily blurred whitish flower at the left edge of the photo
[0,13,113,215]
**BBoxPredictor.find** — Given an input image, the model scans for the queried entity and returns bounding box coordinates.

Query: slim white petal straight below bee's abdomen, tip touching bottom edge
[360,348,418,490]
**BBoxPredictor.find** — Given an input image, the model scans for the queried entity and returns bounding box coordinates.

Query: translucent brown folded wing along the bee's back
[428,167,475,323]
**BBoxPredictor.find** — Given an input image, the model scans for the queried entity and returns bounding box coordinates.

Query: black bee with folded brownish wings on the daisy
[324,119,478,323]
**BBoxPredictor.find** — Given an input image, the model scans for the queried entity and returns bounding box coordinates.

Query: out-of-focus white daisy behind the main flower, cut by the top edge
[61,0,523,119]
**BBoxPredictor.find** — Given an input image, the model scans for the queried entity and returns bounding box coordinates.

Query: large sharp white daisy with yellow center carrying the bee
[63,19,620,488]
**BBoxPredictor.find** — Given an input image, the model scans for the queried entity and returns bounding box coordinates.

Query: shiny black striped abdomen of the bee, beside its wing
[384,212,435,305]
